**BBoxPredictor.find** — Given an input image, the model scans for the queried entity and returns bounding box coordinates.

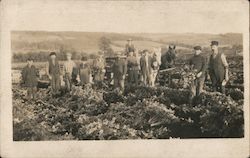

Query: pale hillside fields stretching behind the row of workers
[11,31,243,53]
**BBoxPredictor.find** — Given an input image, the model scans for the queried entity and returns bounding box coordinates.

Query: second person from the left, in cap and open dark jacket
[46,52,61,95]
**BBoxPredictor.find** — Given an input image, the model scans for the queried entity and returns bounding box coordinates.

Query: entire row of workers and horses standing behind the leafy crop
[22,39,229,99]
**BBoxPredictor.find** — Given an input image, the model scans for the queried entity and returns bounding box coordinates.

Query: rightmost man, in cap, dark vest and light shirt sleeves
[209,41,229,94]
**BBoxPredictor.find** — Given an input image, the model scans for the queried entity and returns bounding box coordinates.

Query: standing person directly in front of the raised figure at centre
[127,52,139,85]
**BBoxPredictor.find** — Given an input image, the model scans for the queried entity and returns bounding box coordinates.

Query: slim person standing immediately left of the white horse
[140,50,152,85]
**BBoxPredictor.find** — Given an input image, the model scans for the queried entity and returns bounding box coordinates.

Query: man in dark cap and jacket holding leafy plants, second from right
[189,46,207,99]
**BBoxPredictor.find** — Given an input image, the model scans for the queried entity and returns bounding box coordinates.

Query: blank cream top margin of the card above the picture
[3,0,249,34]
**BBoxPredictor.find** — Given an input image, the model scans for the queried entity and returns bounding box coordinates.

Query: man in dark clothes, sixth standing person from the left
[113,55,127,93]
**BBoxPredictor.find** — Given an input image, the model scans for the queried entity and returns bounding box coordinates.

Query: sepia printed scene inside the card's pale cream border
[11,31,244,141]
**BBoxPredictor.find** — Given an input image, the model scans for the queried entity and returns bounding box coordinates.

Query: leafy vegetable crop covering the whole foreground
[13,85,244,141]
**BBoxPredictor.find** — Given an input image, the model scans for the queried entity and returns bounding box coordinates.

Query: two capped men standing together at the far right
[189,41,229,99]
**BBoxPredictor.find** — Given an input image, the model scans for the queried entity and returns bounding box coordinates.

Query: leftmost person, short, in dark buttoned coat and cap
[22,58,39,100]
